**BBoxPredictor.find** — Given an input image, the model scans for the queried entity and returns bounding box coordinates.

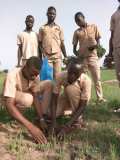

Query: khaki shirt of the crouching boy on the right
[53,71,91,101]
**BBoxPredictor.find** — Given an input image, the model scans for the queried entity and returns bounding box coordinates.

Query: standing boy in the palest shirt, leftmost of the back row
[17,15,39,67]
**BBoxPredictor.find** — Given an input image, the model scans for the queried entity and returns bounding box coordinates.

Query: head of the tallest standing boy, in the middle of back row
[47,6,56,22]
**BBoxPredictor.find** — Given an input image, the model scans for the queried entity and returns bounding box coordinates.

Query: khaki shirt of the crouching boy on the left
[3,68,39,98]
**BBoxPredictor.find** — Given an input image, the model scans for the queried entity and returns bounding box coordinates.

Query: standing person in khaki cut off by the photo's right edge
[108,0,120,86]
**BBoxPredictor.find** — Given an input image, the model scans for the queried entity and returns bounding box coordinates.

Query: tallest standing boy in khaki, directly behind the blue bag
[39,7,67,78]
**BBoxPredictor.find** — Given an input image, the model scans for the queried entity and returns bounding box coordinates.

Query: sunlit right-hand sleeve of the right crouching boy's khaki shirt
[81,76,91,101]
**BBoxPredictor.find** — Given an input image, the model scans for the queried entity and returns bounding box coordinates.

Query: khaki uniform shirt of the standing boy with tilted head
[73,24,101,57]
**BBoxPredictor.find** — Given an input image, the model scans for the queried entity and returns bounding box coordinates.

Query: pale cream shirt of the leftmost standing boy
[17,31,38,60]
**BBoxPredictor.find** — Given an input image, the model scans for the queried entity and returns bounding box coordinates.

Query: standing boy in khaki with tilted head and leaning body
[73,12,105,102]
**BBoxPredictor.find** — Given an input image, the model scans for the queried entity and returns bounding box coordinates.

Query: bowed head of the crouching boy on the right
[67,57,84,84]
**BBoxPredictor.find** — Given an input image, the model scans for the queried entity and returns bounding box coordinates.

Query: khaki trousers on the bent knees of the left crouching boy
[15,80,52,113]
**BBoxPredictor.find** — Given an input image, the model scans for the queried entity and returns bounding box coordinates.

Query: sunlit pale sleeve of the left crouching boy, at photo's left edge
[3,73,16,98]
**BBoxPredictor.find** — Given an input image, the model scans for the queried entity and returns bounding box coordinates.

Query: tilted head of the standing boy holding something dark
[75,12,86,27]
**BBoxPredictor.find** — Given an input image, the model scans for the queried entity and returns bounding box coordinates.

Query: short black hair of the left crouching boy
[26,56,42,70]
